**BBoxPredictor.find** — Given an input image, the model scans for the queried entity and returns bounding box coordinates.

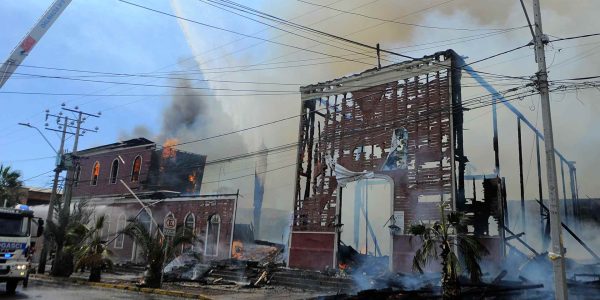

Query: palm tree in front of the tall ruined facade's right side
[408,202,488,299]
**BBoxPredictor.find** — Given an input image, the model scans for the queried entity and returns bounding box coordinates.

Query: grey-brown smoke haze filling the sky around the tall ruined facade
[123,0,600,243]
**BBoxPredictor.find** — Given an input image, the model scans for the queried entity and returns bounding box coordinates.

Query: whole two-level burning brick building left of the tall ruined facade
[68,138,237,262]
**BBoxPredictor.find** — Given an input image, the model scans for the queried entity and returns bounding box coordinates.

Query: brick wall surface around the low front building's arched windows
[97,198,235,262]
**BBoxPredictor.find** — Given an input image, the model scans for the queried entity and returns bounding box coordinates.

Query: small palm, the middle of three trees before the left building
[71,215,113,282]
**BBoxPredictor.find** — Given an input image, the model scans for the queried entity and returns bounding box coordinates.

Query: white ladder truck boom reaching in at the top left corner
[0,0,71,89]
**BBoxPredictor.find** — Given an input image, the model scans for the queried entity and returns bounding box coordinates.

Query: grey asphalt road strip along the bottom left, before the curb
[0,280,181,300]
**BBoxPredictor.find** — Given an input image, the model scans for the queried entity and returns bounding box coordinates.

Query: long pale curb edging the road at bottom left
[30,274,212,300]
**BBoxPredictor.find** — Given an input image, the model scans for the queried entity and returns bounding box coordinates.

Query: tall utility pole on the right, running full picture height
[533,0,567,299]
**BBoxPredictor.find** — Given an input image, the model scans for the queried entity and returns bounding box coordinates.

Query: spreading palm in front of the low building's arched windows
[120,219,196,288]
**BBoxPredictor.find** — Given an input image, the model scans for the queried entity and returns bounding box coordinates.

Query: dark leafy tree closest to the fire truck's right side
[46,200,93,277]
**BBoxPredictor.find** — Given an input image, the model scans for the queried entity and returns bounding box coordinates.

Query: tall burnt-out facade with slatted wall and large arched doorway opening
[289,50,500,271]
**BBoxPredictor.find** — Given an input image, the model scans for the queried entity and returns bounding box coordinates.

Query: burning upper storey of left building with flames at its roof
[73,138,206,197]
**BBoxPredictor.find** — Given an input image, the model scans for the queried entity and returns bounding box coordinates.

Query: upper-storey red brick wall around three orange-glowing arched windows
[73,145,153,197]
